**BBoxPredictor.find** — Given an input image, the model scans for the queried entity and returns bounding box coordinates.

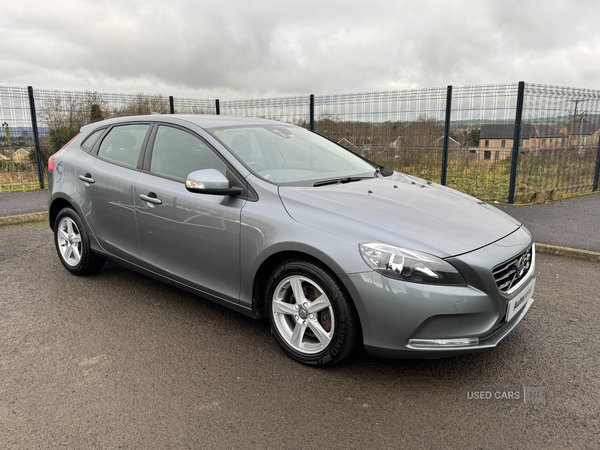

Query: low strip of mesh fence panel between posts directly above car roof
[220,95,310,128]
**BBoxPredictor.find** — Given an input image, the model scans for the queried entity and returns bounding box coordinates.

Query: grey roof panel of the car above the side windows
[81,114,291,132]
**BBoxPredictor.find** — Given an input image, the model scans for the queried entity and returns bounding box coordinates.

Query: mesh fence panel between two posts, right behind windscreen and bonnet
[315,88,446,182]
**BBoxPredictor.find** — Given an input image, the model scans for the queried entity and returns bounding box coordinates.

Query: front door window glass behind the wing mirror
[150,125,227,182]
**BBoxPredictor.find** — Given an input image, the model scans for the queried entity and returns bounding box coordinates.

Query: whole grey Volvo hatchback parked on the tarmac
[49,115,535,366]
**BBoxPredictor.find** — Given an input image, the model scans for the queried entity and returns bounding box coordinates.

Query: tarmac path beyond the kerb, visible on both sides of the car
[0,191,600,252]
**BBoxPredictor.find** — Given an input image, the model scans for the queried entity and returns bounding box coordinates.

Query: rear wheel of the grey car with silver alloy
[54,208,104,275]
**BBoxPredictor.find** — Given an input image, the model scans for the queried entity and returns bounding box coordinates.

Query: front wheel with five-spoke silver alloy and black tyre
[265,259,359,366]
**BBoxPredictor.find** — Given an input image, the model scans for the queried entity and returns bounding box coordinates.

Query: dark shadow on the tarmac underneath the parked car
[86,262,522,384]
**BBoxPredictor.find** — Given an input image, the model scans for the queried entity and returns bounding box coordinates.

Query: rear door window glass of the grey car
[98,124,150,168]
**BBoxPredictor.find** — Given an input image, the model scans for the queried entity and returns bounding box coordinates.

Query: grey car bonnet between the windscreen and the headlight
[279,173,521,258]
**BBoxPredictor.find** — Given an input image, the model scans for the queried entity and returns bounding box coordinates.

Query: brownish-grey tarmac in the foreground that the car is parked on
[0,222,600,450]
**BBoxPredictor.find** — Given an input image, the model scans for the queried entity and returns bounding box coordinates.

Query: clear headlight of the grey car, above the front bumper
[358,243,467,286]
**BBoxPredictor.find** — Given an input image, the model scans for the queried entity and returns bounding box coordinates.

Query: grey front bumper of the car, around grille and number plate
[345,228,535,358]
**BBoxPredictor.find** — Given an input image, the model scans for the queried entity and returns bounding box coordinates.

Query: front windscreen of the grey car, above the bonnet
[208,124,376,185]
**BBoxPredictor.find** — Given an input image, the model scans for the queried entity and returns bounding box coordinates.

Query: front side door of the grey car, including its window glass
[135,125,246,301]
